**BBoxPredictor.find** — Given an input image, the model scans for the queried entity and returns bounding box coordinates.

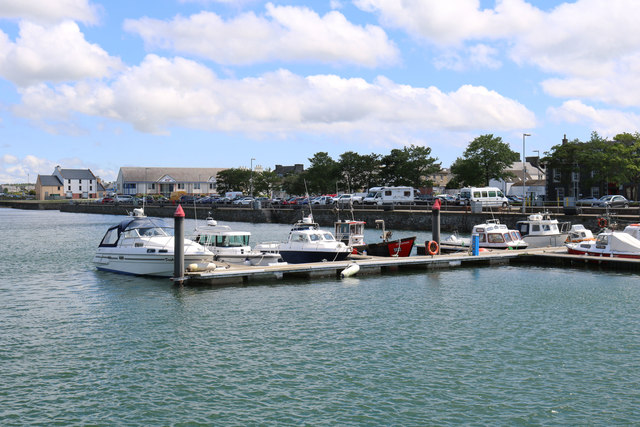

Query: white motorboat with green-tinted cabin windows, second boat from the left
[193,218,281,266]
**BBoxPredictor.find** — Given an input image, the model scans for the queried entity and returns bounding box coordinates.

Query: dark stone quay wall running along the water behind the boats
[0,201,638,233]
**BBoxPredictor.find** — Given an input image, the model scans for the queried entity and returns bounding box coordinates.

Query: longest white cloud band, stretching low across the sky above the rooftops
[15,55,535,133]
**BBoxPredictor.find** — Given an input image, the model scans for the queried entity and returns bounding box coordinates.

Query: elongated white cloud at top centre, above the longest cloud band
[124,3,399,67]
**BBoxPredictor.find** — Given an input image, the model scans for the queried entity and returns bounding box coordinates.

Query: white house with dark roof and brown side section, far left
[36,166,104,200]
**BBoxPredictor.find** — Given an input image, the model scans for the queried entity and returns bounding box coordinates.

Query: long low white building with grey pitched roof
[115,167,225,197]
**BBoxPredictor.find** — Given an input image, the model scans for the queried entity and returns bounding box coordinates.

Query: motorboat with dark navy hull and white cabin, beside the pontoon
[277,215,353,264]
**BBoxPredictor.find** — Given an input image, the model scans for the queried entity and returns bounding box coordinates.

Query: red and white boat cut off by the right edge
[566,229,640,259]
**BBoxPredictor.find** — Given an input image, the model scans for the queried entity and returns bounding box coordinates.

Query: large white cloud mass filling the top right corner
[355,0,640,106]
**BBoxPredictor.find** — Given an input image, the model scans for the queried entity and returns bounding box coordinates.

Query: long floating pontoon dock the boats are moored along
[185,247,640,285]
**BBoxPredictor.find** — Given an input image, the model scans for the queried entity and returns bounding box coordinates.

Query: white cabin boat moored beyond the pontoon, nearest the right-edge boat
[516,213,571,248]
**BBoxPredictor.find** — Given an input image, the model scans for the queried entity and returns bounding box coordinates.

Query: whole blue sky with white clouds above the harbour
[0,0,640,183]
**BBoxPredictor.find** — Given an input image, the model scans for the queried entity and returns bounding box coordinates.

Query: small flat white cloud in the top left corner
[0,0,98,24]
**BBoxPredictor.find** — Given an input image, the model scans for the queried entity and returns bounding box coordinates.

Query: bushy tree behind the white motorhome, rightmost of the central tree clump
[380,144,441,188]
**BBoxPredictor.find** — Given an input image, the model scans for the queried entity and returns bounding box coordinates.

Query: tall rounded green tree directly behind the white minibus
[451,134,520,186]
